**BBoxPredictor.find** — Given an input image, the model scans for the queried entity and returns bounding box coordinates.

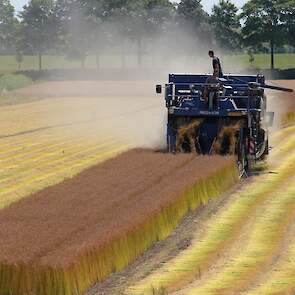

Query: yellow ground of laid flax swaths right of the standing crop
[128,135,295,294]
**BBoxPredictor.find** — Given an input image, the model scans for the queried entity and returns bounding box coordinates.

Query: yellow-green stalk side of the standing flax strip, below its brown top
[0,155,238,295]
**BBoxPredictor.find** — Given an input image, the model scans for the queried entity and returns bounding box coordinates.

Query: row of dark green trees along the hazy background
[0,0,295,70]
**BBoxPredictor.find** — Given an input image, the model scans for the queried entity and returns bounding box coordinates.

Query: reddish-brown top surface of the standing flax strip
[0,149,233,267]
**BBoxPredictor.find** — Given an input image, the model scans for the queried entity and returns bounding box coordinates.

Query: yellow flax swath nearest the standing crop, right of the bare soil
[128,154,295,294]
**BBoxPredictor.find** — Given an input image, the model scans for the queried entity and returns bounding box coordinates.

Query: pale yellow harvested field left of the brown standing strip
[0,82,164,208]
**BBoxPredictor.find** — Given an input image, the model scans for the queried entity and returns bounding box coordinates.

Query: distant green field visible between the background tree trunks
[0,53,295,73]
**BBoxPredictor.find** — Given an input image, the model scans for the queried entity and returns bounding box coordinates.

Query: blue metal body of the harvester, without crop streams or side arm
[165,74,268,163]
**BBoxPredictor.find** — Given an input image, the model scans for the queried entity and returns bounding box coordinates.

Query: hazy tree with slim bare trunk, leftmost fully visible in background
[20,0,58,71]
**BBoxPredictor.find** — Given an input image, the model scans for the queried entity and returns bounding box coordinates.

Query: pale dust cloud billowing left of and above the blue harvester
[16,11,270,149]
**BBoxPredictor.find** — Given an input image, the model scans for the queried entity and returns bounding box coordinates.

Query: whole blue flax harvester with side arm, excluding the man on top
[162,74,293,171]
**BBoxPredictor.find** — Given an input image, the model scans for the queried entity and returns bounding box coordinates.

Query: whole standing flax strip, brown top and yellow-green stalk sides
[0,150,237,295]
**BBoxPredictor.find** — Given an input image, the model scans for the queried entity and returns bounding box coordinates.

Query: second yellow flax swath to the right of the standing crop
[185,178,295,295]
